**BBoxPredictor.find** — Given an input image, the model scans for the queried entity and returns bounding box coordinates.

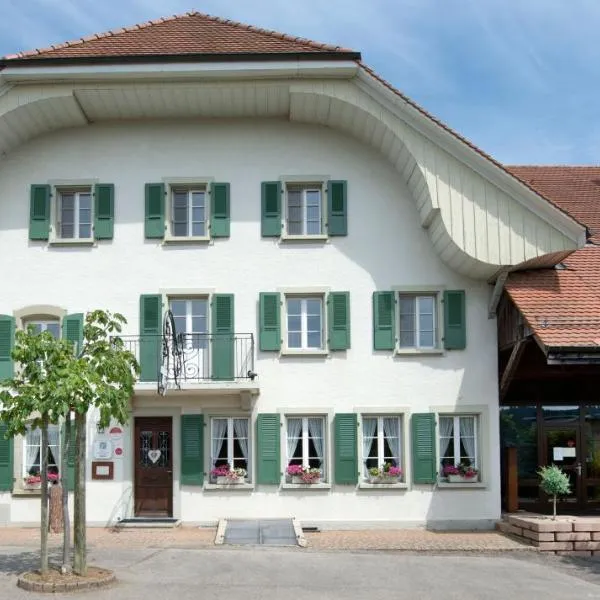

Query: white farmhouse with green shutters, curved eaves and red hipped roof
[0,12,585,527]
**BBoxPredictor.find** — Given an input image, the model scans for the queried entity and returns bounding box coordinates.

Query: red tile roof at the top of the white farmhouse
[4,11,360,61]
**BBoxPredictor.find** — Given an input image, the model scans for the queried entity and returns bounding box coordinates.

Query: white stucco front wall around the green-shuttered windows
[0,120,500,524]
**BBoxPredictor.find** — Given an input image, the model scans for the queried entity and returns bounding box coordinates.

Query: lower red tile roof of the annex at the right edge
[505,166,600,351]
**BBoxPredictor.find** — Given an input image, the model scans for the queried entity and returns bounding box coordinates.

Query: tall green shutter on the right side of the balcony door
[211,294,235,380]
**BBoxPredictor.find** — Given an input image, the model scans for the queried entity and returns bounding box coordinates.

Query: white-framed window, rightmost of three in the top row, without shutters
[285,183,325,236]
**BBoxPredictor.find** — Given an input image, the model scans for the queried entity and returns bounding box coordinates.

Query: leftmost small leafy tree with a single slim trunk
[0,331,73,574]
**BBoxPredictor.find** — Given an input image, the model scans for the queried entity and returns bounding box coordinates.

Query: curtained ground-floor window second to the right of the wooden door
[287,417,327,480]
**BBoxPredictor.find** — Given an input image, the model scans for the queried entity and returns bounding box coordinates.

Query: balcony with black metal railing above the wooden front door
[119,333,258,394]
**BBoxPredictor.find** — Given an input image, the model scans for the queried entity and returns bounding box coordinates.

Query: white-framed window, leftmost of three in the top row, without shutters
[56,187,93,240]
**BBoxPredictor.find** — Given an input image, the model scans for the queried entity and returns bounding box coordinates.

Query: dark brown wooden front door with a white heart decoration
[134,417,173,517]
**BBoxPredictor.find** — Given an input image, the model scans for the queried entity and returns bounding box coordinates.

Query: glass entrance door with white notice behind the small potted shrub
[544,426,584,511]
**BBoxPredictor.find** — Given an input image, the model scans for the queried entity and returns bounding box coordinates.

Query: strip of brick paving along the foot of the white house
[0,527,536,552]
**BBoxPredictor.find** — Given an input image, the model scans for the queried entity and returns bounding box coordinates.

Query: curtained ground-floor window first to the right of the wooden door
[210,417,250,481]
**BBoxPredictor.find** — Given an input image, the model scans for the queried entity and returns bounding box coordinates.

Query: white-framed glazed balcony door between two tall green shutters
[169,298,210,379]
